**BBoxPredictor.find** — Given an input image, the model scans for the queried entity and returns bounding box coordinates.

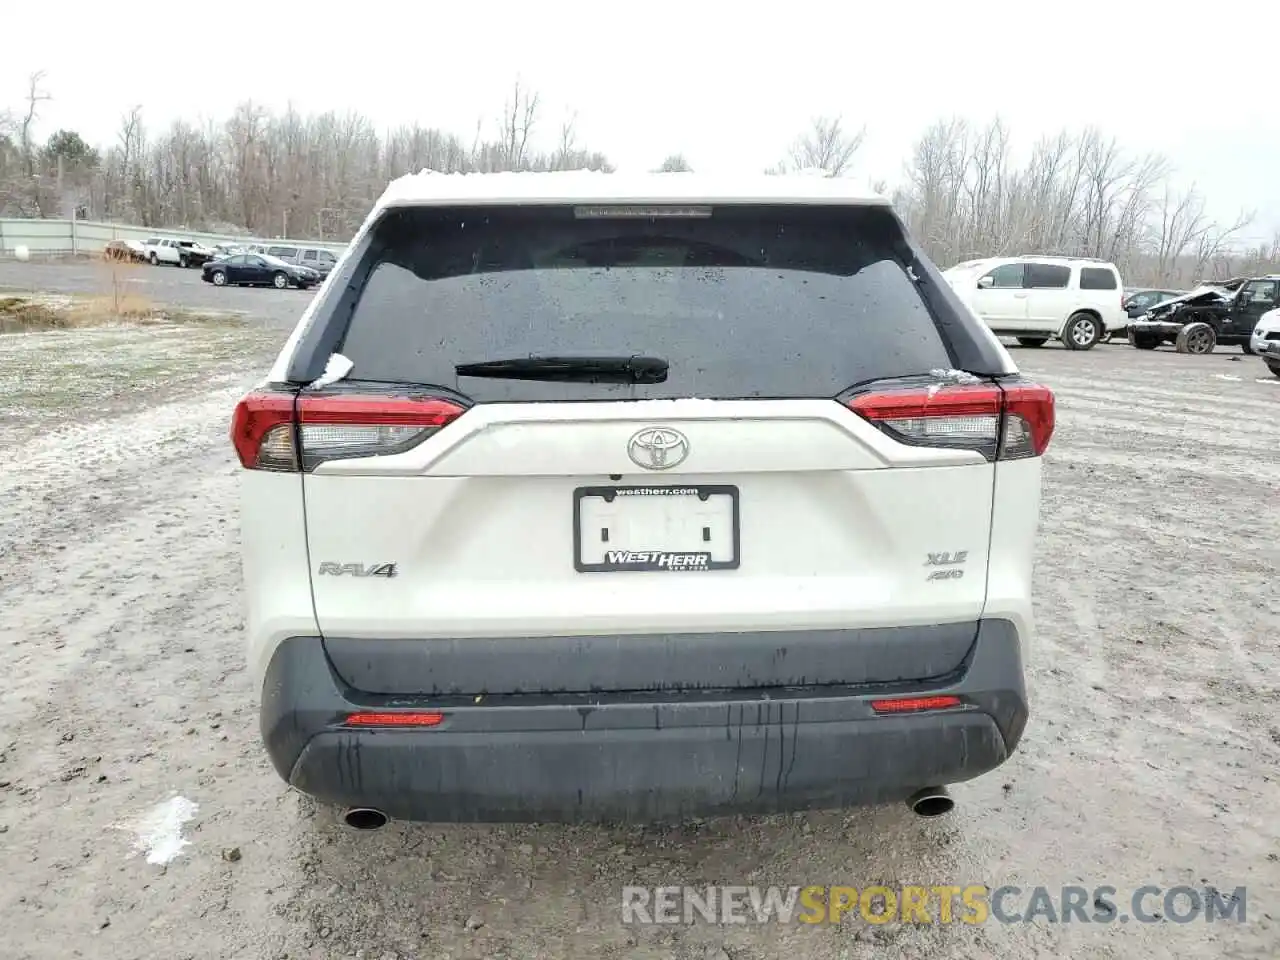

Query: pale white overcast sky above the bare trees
[0,0,1280,239]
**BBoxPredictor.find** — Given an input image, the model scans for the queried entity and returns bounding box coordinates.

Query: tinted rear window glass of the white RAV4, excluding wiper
[340,206,952,401]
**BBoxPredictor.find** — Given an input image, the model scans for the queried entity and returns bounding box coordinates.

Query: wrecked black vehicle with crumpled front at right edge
[1129,275,1280,353]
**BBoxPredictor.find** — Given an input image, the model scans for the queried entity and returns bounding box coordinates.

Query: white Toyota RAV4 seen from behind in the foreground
[232,173,1053,827]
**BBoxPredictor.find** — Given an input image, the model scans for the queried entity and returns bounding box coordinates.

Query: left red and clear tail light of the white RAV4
[232,392,466,472]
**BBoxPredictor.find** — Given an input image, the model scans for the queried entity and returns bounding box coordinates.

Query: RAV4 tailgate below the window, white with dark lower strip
[305,401,995,692]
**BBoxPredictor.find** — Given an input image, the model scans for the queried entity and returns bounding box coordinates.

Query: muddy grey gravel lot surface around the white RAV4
[0,265,1280,960]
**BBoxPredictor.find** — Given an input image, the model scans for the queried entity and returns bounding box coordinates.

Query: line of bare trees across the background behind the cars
[0,73,1280,287]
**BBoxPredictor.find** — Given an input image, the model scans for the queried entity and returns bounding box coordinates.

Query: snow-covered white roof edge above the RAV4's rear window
[375,170,890,209]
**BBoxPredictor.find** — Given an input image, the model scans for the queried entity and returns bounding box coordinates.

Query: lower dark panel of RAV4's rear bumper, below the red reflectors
[293,704,1007,823]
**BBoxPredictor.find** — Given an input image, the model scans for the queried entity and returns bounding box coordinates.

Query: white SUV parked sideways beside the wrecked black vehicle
[943,256,1129,349]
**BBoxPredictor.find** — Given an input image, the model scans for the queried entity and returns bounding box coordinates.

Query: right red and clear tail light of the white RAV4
[849,381,1053,460]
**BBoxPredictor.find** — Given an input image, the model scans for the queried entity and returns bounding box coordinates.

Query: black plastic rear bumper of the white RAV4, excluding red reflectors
[261,621,1028,822]
